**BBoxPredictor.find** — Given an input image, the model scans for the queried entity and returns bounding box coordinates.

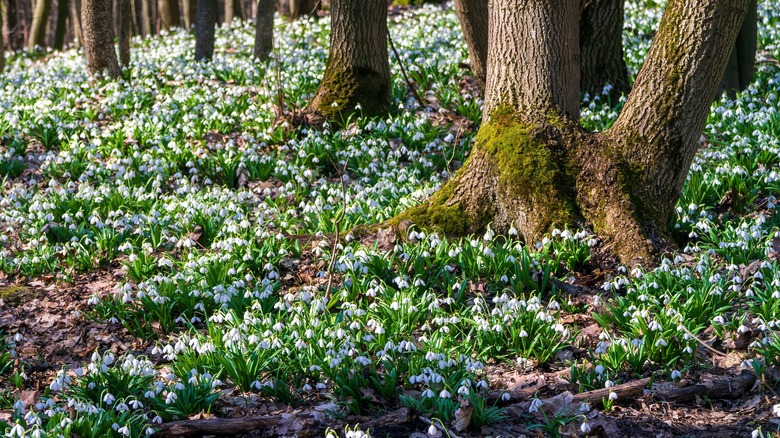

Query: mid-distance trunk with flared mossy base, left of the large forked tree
[305,0,390,124]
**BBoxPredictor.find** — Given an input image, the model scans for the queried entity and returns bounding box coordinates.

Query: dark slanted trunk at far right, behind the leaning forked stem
[718,0,758,98]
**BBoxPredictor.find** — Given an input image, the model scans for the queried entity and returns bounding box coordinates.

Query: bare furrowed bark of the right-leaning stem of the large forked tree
[605,0,751,232]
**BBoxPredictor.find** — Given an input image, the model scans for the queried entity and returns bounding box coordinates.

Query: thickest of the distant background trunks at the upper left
[81,0,121,78]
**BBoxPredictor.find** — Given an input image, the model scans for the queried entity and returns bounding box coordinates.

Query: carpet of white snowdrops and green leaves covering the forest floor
[0,1,780,436]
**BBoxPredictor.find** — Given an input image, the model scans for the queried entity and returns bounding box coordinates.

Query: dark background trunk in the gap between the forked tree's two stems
[580,0,629,97]
